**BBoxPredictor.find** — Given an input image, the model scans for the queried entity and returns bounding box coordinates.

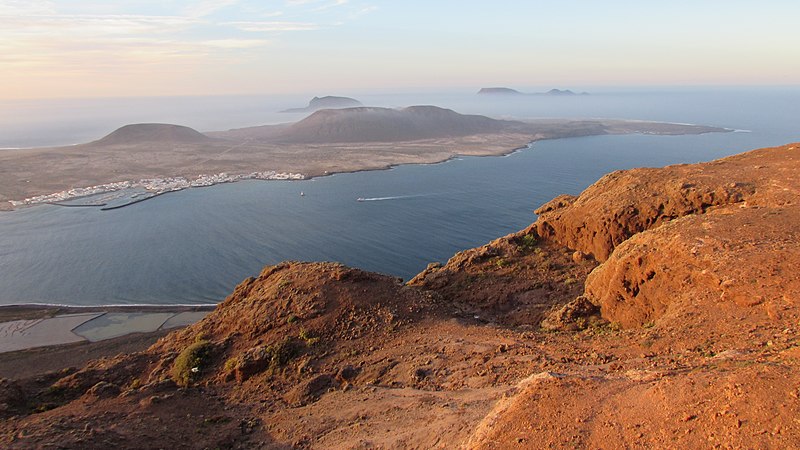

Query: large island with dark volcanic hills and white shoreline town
[0,105,729,210]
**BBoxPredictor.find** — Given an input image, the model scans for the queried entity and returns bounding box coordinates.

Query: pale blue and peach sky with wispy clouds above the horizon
[0,0,800,100]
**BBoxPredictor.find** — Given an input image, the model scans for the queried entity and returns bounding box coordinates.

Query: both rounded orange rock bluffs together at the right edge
[534,145,800,327]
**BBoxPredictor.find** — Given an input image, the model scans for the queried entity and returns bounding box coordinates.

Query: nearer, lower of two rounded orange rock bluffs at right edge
[586,205,800,327]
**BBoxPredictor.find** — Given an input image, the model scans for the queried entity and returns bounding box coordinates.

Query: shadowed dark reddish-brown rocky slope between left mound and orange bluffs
[408,229,597,328]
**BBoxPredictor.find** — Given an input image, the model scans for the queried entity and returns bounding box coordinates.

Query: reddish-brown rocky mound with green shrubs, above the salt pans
[149,262,436,382]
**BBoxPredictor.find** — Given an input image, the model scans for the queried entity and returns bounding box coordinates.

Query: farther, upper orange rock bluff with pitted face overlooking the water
[536,145,797,261]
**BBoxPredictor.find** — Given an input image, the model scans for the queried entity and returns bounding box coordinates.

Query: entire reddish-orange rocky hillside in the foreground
[0,144,800,449]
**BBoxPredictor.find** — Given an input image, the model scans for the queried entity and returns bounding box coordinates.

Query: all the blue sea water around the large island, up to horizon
[0,87,800,306]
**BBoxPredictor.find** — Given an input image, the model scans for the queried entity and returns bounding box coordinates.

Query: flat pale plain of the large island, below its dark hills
[0,119,731,211]
